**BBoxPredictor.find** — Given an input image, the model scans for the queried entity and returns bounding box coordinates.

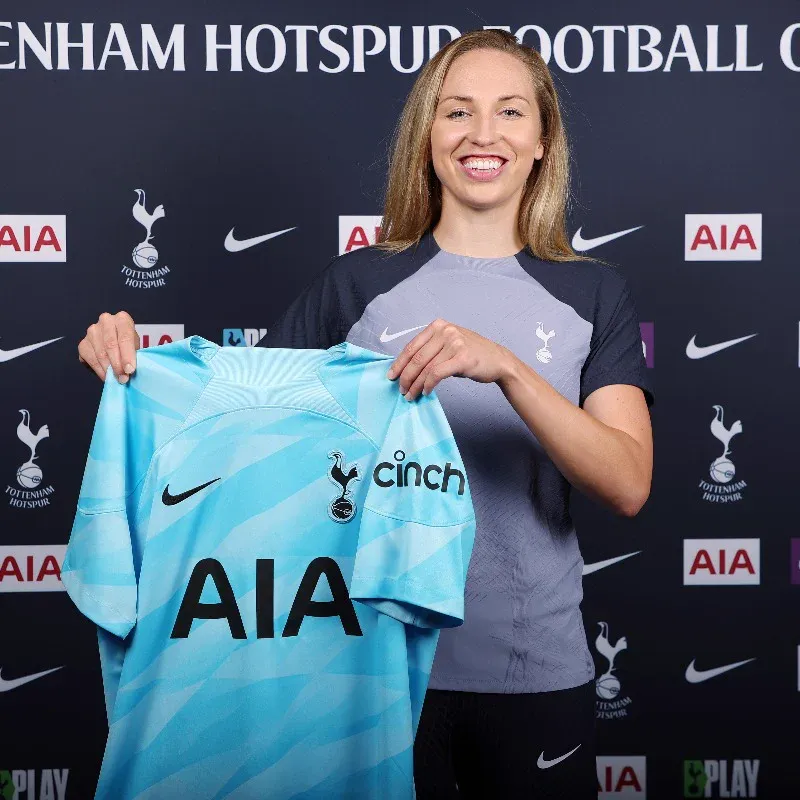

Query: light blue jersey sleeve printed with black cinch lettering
[350,390,475,628]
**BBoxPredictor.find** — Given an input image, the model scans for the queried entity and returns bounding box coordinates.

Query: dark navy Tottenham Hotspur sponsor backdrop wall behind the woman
[0,0,800,800]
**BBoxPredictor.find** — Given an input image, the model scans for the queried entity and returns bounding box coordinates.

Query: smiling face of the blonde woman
[431,50,544,214]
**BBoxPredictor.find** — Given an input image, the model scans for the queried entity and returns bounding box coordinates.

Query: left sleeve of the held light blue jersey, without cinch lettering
[61,337,216,638]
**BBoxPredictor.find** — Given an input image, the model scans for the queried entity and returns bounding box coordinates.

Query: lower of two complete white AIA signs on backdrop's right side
[683,539,761,586]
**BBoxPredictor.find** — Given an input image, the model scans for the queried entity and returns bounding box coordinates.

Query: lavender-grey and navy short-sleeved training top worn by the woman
[259,231,653,693]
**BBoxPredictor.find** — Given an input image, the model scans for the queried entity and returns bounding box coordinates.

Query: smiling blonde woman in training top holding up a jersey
[79,31,653,800]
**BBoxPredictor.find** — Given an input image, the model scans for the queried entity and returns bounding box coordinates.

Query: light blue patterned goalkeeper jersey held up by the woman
[62,336,475,800]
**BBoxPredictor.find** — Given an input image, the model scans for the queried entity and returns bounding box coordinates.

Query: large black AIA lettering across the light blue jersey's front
[169,557,364,639]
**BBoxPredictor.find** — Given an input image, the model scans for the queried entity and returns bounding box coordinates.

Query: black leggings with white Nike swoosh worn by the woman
[414,681,597,800]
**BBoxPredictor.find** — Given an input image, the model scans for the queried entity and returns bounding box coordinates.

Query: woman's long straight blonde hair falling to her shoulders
[377,30,588,261]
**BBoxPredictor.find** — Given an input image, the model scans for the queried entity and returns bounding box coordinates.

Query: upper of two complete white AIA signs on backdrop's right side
[684,214,762,261]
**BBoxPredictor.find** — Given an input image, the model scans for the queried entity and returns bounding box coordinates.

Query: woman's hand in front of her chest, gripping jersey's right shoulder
[387,319,514,400]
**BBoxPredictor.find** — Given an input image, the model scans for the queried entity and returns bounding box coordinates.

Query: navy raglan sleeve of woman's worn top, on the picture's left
[258,232,438,350]
